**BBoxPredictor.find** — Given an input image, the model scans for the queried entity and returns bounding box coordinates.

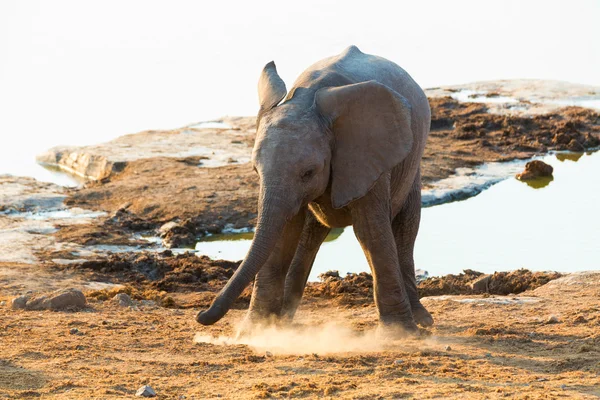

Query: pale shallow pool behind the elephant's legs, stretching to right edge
[196,152,600,280]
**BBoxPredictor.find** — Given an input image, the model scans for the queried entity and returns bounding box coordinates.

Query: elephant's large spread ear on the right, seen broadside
[315,81,413,208]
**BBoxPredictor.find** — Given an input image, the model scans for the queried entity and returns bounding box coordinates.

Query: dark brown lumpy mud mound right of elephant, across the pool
[421,97,600,188]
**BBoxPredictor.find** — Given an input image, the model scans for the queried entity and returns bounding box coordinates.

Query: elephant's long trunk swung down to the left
[196,190,286,325]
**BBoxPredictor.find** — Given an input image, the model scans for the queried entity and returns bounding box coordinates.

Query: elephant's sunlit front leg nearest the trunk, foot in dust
[239,208,306,334]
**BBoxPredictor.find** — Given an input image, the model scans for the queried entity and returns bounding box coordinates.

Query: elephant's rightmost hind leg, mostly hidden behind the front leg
[392,175,433,326]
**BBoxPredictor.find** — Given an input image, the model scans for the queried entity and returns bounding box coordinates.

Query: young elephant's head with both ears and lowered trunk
[197,62,413,325]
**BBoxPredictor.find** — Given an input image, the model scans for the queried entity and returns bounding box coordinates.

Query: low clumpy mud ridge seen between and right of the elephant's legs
[306,269,561,305]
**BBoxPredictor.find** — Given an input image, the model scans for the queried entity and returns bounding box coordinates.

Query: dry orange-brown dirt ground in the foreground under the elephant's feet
[0,265,600,399]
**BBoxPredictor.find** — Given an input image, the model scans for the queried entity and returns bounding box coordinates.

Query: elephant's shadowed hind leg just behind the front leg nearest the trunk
[281,212,331,321]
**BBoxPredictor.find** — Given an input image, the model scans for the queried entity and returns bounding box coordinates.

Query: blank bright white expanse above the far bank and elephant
[0,0,600,178]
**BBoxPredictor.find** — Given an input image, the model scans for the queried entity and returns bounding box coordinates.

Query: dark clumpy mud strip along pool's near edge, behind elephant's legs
[55,250,562,307]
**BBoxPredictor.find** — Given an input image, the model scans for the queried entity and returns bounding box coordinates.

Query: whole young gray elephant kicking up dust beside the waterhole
[196,46,433,331]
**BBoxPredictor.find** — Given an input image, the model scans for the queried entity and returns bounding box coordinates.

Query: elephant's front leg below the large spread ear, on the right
[352,180,418,333]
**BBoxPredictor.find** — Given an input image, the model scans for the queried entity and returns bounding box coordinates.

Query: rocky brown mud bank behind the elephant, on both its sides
[0,80,600,268]
